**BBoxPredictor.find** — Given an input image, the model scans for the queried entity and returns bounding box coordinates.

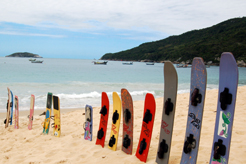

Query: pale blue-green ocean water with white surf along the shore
[0,57,246,112]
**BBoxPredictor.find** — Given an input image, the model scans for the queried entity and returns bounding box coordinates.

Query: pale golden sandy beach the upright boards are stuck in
[0,86,246,164]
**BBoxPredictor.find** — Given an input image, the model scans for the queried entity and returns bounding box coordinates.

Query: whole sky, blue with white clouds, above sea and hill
[0,0,246,59]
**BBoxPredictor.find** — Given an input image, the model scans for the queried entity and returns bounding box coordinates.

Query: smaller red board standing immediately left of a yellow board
[96,92,109,147]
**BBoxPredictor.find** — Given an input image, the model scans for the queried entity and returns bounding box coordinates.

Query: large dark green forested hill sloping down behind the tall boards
[101,17,246,63]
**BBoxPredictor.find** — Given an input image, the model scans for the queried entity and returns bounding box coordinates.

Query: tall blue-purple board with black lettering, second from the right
[180,57,207,164]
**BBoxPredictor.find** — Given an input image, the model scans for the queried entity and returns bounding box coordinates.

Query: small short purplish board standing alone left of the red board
[84,105,93,141]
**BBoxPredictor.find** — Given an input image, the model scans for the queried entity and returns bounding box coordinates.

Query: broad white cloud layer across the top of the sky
[0,0,246,35]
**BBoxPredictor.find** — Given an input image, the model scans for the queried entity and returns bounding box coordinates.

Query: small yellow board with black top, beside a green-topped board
[53,96,61,137]
